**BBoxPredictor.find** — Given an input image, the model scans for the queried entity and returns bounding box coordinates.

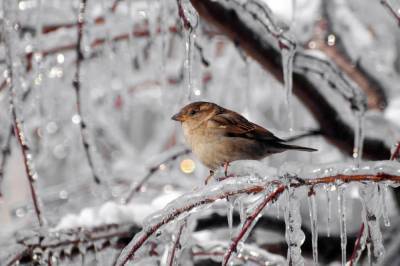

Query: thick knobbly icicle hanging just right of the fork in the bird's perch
[285,187,305,265]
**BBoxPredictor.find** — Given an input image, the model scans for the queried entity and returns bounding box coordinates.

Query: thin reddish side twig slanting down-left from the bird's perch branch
[222,185,286,266]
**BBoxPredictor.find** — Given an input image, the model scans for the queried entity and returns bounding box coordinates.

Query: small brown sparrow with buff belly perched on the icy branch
[171,101,317,184]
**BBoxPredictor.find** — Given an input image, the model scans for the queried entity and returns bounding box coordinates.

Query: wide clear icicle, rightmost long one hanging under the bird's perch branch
[361,183,385,265]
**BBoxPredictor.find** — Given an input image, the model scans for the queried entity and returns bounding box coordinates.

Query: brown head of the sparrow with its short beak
[171,102,222,124]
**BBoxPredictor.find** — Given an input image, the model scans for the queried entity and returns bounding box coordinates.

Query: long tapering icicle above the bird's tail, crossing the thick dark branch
[280,39,296,132]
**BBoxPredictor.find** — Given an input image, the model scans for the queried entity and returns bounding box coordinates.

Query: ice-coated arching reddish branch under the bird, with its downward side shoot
[116,163,400,265]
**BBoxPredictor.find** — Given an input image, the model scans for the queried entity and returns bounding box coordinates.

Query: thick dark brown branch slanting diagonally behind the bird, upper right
[191,0,390,160]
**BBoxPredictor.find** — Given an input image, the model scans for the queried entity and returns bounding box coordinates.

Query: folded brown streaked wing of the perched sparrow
[207,111,284,142]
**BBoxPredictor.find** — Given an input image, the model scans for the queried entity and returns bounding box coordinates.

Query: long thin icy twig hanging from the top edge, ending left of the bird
[72,0,100,184]
